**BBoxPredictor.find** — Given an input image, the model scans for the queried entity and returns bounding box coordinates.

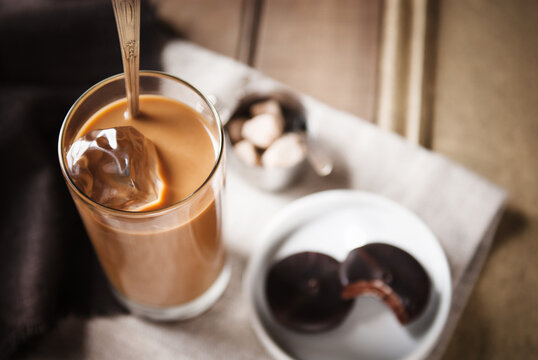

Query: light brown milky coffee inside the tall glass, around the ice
[77,95,225,307]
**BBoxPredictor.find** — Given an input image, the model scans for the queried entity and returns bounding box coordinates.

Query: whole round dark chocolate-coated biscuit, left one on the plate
[265,252,354,333]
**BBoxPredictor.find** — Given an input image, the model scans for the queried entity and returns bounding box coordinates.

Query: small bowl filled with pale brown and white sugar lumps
[225,91,307,191]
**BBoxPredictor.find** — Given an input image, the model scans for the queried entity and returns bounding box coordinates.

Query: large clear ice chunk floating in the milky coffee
[67,126,164,211]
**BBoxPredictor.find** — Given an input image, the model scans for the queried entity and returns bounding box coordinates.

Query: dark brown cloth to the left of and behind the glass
[0,0,174,358]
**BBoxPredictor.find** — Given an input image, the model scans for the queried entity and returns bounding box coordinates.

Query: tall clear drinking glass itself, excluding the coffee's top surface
[58,71,230,320]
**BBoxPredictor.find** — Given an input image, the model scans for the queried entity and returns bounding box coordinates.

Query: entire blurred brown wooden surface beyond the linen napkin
[153,0,538,359]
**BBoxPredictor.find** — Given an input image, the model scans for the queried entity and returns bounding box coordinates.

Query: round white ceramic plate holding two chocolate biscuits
[244,190,452,360]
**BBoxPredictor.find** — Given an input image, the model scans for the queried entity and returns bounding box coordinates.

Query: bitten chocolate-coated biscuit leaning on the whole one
[340,243,431,324]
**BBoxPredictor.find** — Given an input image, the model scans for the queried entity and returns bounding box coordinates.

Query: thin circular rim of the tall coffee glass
[58,70,224,217]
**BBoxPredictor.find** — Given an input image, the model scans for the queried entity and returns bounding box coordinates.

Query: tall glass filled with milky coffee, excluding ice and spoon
[59,72,230,320]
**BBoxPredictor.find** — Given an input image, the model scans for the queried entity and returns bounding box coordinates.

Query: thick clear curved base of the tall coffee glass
[112,260,232,321]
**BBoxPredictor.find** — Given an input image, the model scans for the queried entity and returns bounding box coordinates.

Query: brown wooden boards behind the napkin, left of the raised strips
[155,0,381,121]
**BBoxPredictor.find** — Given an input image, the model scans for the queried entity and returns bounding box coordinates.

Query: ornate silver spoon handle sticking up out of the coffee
[112,0,140,119]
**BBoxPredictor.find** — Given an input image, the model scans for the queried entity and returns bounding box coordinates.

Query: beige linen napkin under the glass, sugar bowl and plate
[28,41,506,360]
